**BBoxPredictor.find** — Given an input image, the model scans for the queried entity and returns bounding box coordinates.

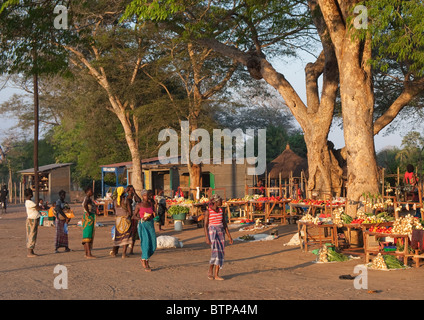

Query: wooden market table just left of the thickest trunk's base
[297,221,338,252]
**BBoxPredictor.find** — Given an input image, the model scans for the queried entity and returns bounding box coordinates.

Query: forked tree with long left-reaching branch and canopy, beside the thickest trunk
[127,0,342,198]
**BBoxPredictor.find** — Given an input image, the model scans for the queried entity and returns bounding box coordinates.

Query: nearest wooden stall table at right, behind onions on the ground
[363,230,409,266]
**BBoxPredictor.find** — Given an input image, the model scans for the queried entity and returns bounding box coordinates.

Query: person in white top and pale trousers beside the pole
[24,189,40,258]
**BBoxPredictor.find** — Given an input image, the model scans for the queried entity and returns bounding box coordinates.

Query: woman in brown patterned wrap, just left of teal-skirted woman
[110,187,133,259]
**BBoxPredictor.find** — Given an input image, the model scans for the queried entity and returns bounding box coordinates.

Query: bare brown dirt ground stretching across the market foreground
[0,204,424,300]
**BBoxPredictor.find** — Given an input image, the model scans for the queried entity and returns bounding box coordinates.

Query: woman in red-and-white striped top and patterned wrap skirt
[204,194,233,280]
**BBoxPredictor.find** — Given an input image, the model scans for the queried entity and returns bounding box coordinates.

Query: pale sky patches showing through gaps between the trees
[0,51,403,152]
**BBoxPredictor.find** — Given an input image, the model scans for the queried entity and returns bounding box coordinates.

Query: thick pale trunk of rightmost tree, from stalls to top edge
[318,0,379,216]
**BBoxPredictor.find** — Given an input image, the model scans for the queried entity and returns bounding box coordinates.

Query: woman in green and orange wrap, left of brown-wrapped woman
[82,187,96,259]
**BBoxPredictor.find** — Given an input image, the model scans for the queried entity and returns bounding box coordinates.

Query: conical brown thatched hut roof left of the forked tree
[268,144,308,179]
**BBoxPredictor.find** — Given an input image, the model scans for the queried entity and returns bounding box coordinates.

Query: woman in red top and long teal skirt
[136,190,156,272]
